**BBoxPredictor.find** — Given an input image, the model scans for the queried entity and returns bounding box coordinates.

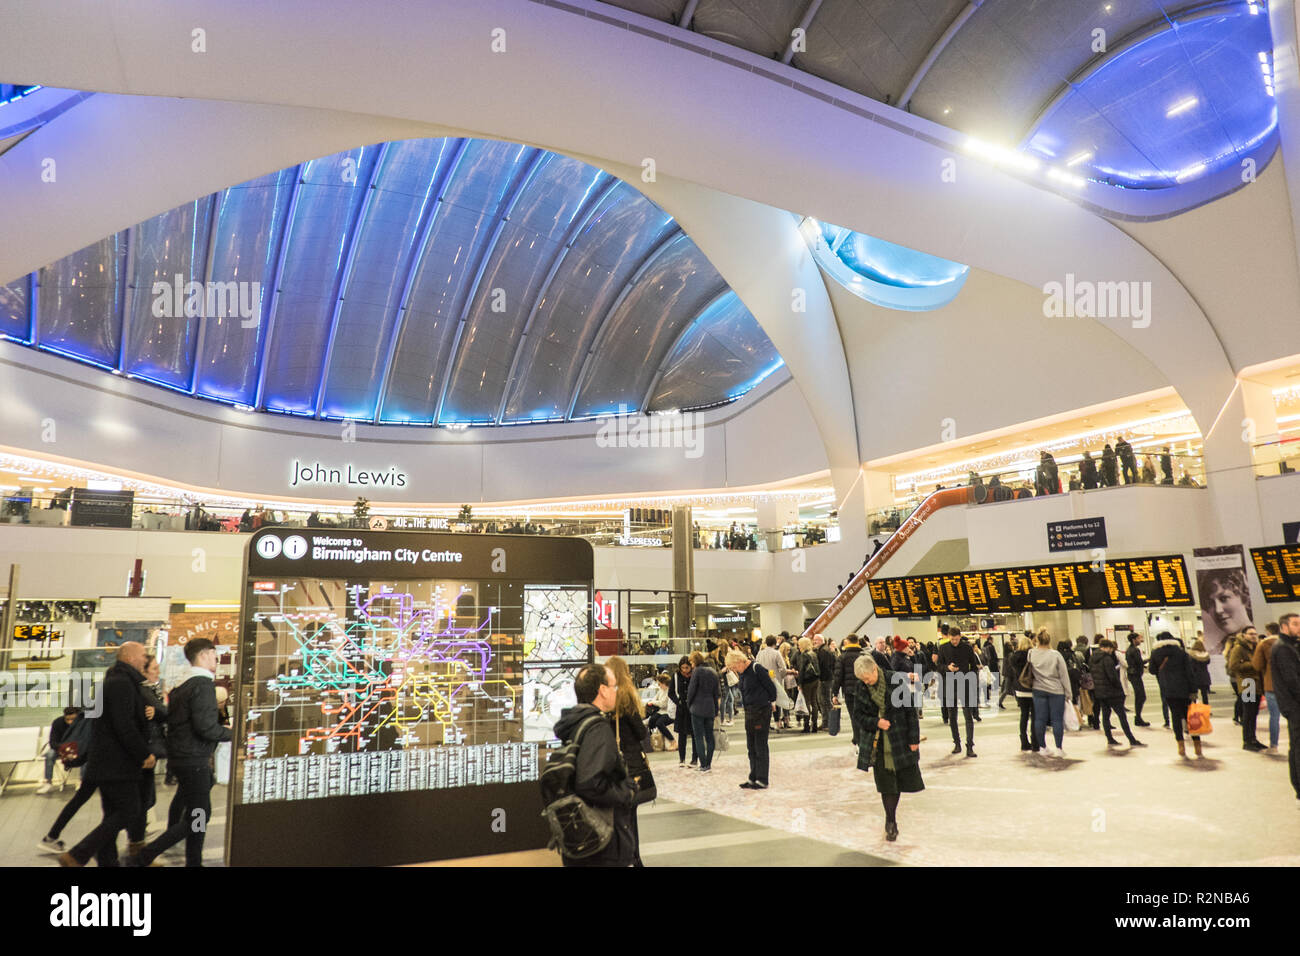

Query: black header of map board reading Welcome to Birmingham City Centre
[248,528,595,581]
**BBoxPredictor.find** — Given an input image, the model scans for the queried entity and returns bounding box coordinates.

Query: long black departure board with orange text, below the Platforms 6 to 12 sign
[868,548,1190,618]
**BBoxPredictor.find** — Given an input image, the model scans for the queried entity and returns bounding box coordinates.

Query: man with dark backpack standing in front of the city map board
[542,663,638,866]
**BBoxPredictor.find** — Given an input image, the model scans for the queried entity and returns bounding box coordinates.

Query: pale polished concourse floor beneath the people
[0,693,1300,866]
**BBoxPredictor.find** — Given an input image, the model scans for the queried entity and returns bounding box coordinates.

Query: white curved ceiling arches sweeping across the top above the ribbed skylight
[0,0,1289,465]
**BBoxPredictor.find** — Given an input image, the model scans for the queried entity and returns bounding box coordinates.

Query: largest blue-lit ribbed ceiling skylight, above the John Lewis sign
[0,139,780,425]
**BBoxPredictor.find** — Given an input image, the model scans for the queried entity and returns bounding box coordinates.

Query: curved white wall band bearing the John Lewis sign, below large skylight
[0,342,827,505]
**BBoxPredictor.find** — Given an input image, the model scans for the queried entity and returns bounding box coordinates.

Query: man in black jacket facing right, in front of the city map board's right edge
[553,663,634,866]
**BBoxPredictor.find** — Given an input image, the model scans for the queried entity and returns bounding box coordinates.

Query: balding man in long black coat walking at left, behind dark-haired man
[59,641,156,866]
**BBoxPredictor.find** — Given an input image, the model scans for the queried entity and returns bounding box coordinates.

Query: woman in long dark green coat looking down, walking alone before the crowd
[853,654,926,842]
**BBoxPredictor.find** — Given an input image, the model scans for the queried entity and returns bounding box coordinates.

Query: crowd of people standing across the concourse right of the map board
[543,614,1300,866]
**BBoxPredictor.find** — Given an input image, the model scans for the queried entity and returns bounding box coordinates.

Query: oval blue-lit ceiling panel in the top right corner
[1026,3,1278,189]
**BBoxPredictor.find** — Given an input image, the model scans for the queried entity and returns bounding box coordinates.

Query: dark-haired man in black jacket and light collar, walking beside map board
[129,637,230,866]
